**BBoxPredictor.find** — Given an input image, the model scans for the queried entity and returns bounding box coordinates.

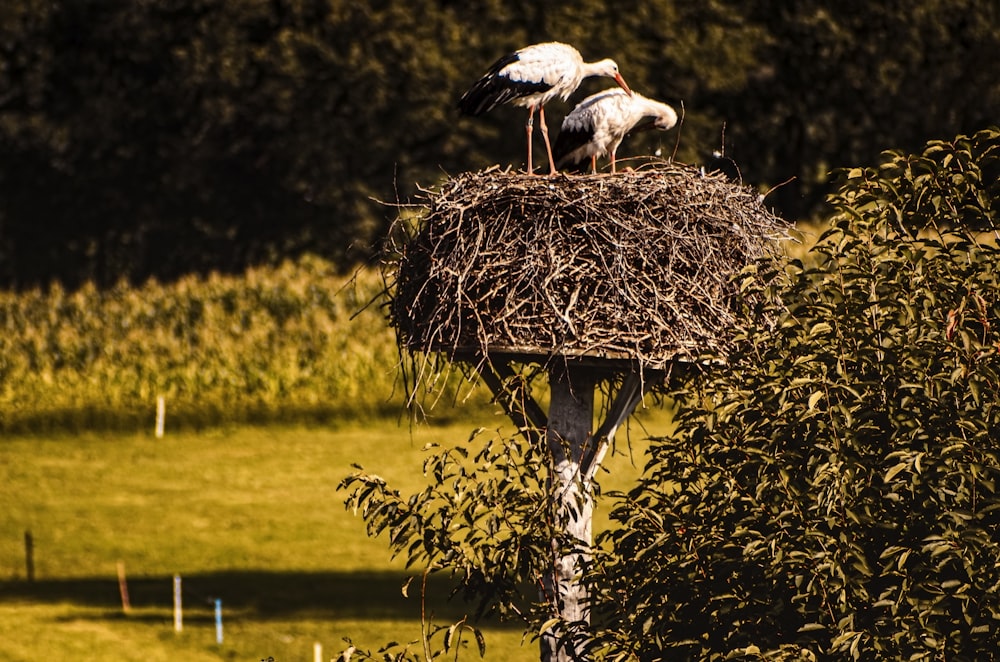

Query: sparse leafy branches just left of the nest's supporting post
[339,428,552,662]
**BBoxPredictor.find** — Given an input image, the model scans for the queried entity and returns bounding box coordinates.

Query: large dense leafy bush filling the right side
[589,129,1000,660]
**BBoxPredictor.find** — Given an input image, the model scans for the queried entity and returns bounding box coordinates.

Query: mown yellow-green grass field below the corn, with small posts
[0,410,668,662]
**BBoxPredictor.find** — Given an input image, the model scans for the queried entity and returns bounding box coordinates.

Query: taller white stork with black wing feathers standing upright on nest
[458,41,632,174]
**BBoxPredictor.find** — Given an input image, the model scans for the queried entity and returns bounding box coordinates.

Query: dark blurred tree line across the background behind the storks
[0,0,1000,287]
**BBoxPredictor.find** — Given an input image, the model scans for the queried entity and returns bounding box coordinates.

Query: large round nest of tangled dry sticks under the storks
[390,162,786,369]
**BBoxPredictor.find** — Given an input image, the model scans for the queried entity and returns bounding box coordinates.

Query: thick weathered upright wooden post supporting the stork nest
[541,365,597,662]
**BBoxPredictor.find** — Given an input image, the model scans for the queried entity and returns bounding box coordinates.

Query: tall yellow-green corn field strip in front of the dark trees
[0,257,401,432]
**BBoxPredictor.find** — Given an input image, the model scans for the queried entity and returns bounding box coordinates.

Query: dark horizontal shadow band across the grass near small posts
[0,570,517,627]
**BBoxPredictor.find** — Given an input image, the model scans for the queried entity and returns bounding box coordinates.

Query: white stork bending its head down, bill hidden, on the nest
[554,87,677,172]
